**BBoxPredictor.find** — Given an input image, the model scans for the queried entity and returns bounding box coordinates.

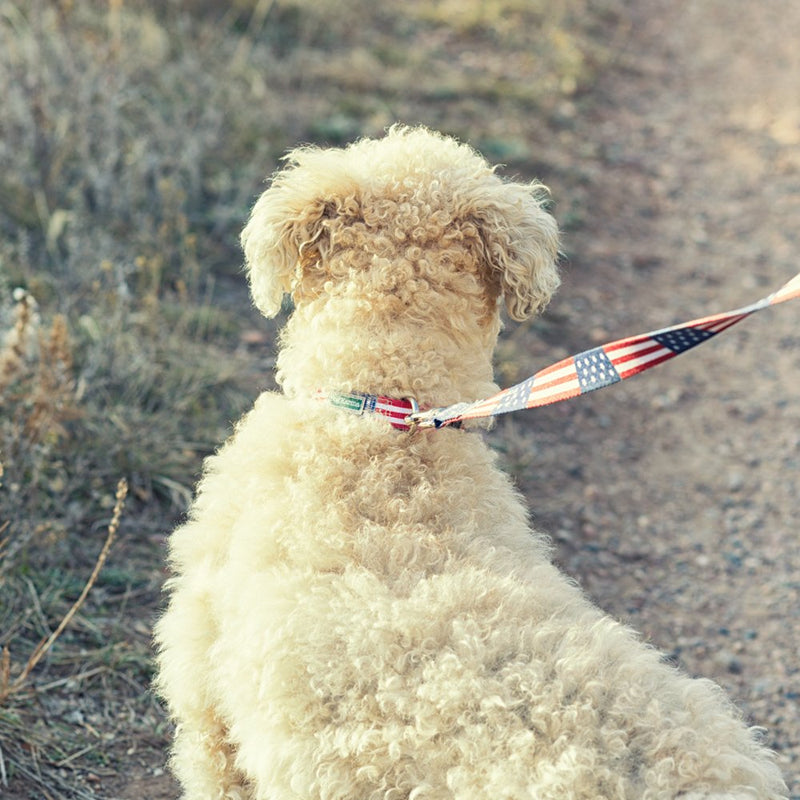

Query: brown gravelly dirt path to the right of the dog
[503,0,800,797]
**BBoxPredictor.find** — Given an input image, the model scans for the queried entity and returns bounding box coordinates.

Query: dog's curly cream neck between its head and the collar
[277,299,499,407]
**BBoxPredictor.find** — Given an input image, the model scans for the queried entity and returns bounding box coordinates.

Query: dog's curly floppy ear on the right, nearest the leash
[475,176,560,320]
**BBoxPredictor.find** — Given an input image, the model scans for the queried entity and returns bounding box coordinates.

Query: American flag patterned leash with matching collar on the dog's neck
[319,273,800,430]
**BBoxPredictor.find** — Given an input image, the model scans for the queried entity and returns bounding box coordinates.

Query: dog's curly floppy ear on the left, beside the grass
[242,156,332,317]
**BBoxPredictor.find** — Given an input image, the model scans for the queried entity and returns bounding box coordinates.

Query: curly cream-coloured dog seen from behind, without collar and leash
[157,127,785,800]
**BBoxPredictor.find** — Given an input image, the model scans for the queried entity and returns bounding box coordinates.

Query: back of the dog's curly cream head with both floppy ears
[242,126,559,320]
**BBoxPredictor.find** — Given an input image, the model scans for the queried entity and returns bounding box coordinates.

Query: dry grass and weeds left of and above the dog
[0,0,617,798]
